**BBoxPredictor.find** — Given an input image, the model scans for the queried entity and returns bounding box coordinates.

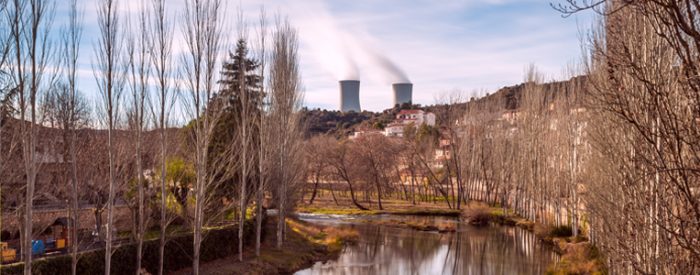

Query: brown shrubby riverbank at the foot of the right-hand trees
[464,202,607,274]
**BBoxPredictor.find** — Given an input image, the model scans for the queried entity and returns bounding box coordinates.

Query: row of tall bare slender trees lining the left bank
[0,0,303,274]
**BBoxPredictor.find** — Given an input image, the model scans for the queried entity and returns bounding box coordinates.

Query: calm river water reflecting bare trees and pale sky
[296,215,558,275]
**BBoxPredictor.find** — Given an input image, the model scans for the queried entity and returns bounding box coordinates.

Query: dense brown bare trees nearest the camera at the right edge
[558,0,700,274]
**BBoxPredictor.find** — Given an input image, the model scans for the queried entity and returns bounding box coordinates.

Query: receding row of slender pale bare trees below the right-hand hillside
[454,67,590,235]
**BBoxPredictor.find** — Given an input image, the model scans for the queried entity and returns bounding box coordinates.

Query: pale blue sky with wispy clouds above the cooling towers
[53,0,593,115]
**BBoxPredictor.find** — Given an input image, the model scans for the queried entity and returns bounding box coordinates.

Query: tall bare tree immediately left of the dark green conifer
[181,0,223,274]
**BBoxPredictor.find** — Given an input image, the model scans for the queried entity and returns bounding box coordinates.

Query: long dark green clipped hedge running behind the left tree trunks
[0,221,265,275]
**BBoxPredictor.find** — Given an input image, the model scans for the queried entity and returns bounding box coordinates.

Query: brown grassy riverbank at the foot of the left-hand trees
[172,218,357,275]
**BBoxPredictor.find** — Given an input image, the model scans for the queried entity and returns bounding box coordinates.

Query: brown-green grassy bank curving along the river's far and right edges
[296,196,607,274]
